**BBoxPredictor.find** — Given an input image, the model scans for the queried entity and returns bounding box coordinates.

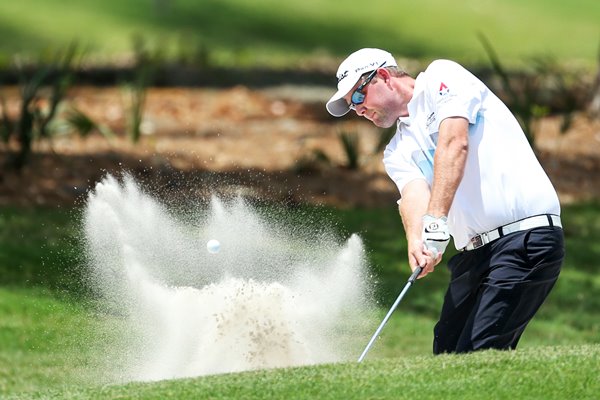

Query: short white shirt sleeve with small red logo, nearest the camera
[425,60,482,130]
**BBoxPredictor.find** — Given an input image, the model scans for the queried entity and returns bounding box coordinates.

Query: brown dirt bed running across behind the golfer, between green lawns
[0,86,600,207]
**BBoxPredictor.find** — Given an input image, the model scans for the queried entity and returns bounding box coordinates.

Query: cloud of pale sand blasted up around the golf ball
[83,175,377,381]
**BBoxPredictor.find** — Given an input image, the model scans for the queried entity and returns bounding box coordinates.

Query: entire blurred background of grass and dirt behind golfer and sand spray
[0,0,600,397]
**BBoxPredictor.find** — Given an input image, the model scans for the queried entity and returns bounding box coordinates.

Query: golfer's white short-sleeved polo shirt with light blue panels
[383,60,560,249]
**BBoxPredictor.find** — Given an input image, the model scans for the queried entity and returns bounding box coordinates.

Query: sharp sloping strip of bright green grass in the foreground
[16,345,600,400]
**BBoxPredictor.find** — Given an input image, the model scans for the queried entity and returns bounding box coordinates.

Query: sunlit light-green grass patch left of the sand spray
[0,289,102,398]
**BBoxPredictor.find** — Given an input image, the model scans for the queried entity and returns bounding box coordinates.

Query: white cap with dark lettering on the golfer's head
[327,48,398,117]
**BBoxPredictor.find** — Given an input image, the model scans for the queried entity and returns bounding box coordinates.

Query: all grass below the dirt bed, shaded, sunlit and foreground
[0,203,600,399]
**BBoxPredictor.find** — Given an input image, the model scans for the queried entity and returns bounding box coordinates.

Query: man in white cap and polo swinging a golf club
[327,49,564,354]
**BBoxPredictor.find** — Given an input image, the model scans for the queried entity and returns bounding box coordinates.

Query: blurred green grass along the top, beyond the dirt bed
[0,0,600,66]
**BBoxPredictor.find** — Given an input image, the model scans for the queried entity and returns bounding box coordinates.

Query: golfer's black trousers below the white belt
[433,227,565,354]
